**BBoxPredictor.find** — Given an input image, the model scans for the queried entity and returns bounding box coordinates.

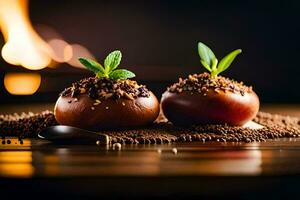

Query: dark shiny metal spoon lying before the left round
[38,125,109,144]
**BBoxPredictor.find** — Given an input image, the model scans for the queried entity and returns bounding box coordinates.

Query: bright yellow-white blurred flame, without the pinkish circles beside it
[0,0,52,70]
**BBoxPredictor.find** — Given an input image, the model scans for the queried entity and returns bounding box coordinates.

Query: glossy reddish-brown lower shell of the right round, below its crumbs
[161,90,259,126]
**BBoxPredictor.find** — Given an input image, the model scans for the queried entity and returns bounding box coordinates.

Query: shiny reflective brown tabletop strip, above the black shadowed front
[0,138,300,178]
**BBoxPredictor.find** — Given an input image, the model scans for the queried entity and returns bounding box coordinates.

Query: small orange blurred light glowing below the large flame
[4,73,41,95]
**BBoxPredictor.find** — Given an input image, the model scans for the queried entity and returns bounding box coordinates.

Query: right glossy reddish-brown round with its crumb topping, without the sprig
[161,73,259,126]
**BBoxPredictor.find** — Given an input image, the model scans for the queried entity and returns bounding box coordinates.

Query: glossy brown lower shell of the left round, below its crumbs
[54,92,159,131]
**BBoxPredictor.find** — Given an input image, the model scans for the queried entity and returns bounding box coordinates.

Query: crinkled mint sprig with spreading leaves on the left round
[78,50,135,80]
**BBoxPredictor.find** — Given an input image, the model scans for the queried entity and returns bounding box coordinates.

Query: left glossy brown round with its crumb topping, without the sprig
[54,77,159,131]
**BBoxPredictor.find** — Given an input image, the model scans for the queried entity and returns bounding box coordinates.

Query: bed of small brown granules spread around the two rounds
[0,111,300,144]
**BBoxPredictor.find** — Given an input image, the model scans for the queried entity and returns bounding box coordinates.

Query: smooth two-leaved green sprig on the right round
[198,42,242,77]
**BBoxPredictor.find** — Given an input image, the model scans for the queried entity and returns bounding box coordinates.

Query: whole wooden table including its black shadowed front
[0,106,300,199]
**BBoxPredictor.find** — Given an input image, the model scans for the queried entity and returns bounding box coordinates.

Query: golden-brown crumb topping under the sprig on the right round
[168,72,252,96]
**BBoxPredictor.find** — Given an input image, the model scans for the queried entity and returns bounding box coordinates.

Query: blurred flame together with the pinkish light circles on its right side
[0,0,93,70]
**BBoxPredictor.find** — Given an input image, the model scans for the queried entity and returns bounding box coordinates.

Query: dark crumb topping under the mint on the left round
[60,77,150,101]
